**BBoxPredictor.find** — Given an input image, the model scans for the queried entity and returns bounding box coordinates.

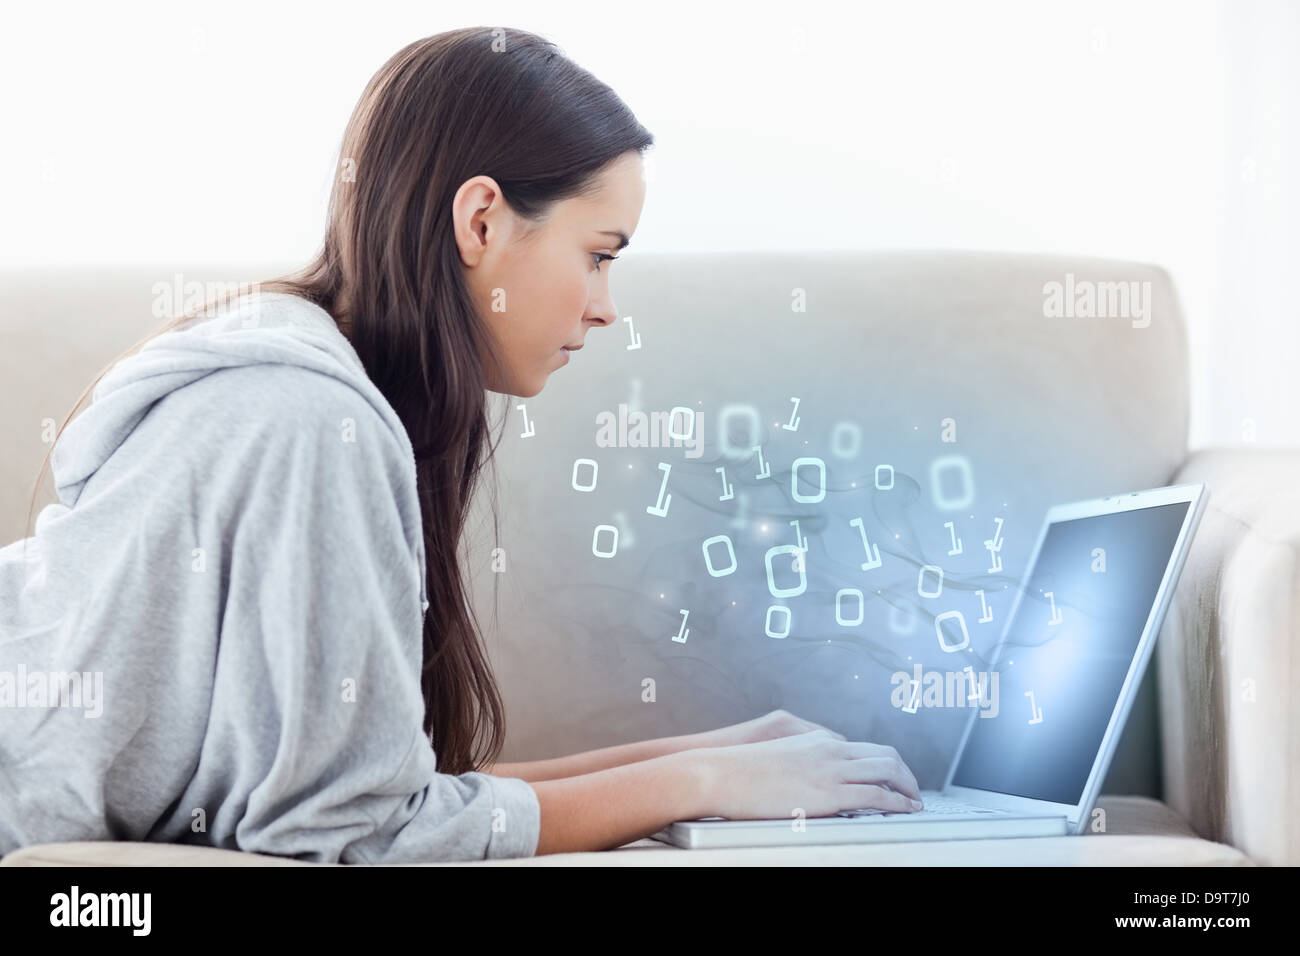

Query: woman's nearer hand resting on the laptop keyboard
[683,727,922,819]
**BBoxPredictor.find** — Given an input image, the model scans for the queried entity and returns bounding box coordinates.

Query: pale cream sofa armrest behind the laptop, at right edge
[1156,447,1300,865]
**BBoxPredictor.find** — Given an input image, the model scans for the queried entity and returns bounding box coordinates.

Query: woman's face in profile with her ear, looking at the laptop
[452,151,645,398]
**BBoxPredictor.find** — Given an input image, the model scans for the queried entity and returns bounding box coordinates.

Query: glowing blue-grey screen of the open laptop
[952,502,1190,804]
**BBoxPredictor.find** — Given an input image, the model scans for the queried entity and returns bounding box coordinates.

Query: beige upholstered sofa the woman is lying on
[0,251,1300,866]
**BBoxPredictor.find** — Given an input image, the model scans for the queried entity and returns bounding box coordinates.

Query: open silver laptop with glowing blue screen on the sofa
[654,484,1209,849]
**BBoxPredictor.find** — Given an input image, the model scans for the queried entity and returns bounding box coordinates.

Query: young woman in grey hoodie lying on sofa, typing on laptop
[0,29,919,862]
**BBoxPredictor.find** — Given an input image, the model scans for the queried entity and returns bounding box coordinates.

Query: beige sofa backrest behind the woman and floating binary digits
[0,252,1188,795]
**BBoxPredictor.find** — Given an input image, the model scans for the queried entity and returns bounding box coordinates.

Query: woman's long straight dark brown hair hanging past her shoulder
[27,27,654,774]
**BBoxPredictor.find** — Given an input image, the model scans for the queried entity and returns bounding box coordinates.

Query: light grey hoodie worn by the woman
[0,294,541,864]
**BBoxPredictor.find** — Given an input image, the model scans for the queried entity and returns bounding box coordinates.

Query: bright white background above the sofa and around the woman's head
[0,0,1300,447]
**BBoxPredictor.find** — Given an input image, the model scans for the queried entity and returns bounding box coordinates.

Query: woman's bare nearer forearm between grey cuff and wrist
[530,741,714,856]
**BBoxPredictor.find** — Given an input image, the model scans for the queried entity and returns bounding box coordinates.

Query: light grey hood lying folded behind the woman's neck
[51,293,415,507]
